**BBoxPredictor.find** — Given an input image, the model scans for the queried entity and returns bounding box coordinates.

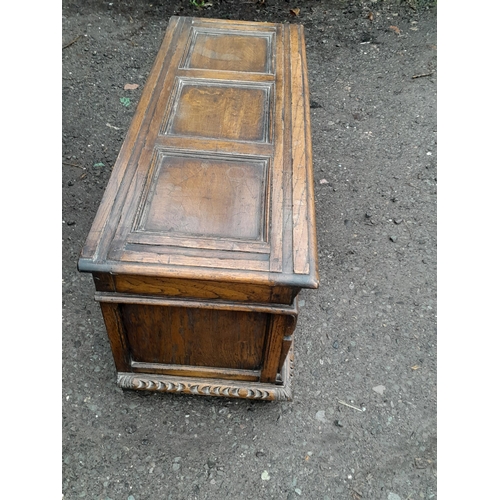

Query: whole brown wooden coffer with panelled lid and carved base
[78,17,318,400]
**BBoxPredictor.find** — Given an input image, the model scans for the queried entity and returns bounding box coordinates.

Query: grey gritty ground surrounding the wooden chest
[62,0,437,500]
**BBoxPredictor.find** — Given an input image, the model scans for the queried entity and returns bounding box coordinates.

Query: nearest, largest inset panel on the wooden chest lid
[136,153,267,241]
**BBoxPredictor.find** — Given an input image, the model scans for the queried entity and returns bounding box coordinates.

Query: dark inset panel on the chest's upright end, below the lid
[120,304,268,370]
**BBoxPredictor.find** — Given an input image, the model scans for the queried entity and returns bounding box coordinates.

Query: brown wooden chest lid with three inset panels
[78,17,318,288]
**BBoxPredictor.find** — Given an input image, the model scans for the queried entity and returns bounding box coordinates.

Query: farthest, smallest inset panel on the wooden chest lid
[182,28,273,73]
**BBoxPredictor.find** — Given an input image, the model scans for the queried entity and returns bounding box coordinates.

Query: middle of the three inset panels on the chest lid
[165,79,272,142]
